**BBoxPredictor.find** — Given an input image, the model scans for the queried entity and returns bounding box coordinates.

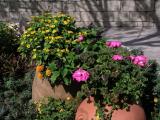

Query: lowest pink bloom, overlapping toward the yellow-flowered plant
[72,68,89,82]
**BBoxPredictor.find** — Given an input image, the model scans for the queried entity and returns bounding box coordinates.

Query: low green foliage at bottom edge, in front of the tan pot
[37,99,79,120]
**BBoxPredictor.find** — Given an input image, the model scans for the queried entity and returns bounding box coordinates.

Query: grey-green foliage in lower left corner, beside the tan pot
[0,72,36,120]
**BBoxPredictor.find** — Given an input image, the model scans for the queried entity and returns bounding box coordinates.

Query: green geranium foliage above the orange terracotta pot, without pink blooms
[73,44,156,118]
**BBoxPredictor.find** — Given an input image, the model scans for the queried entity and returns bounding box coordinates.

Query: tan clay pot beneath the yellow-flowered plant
[32,73,76,102]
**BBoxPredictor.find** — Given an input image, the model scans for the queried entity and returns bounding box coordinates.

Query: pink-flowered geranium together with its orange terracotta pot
[75,41,151,120]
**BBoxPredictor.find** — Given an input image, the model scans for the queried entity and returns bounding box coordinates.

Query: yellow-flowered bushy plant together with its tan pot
[18,13,100,101]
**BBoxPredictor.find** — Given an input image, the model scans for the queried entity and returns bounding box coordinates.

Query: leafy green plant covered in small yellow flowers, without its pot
[18,13,98,85]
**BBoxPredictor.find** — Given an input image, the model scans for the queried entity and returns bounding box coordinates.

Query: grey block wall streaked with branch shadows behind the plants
[0,0,160,27]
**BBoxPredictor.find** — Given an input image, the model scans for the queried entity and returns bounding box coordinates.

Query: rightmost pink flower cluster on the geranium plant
[129,55,148,67]
